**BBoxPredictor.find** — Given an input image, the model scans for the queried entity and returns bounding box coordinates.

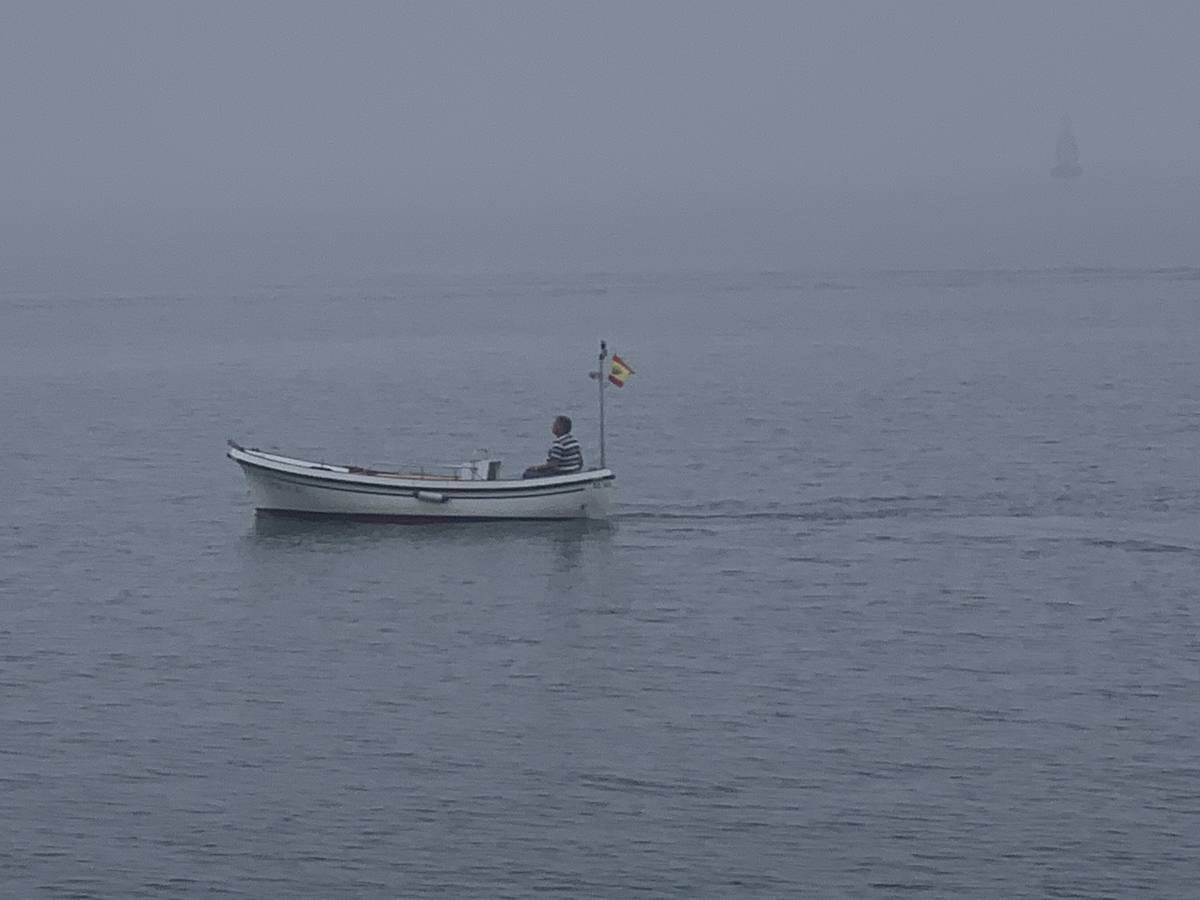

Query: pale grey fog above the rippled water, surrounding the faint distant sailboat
[0,0,1200,290]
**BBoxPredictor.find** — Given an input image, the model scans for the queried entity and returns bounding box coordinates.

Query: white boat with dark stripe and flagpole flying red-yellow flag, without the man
[226,341,631,522]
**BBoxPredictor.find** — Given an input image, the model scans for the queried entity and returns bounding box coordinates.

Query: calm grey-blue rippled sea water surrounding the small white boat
[0,270,1200,898]
